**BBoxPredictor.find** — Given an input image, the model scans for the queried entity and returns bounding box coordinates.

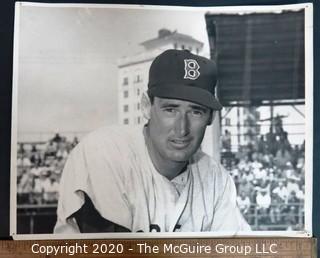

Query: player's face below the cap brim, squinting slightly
[148,97,212,162]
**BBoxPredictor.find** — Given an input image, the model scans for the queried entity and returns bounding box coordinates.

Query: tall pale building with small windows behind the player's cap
[118,29,203,125]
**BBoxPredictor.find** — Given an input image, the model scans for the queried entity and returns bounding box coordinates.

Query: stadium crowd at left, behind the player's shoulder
[17,133,78,204]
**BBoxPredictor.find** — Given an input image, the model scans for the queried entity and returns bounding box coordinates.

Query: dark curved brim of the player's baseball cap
[148,85,222,110]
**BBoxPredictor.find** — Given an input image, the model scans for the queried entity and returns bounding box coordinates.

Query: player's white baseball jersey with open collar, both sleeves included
[55,127,250,233]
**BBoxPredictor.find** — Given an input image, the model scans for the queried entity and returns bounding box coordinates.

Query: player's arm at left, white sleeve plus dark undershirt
[54,128,132,234]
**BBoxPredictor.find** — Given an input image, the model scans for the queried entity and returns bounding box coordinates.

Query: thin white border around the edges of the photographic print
[10,2,314,240]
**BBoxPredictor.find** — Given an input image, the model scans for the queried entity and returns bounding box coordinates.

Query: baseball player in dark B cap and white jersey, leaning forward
[55,50,250,234]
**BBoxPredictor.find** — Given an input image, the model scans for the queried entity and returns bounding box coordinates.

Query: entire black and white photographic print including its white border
[10,2,313,239]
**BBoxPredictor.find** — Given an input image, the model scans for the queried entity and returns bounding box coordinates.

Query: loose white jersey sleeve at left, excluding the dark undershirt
[54,130,132,234]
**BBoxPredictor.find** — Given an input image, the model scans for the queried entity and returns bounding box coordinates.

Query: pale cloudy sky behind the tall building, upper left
[16,6,209,141]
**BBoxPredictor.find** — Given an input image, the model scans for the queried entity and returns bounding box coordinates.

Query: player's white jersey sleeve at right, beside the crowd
[211,167,251,234]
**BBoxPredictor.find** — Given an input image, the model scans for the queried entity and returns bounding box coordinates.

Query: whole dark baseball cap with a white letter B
[148,49,222,110]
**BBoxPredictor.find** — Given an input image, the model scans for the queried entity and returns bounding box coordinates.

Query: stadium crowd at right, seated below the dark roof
[222,119,305,230]
